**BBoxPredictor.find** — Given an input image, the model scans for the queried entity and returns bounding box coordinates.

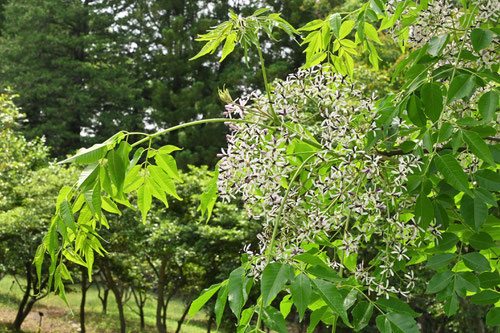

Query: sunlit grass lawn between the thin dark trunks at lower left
[0,276,207,333]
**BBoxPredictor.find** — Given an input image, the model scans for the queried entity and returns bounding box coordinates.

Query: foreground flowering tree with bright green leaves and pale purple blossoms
[36,0,500,332]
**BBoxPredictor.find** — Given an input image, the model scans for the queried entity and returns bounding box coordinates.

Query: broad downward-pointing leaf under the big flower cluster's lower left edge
[261,262,293,306]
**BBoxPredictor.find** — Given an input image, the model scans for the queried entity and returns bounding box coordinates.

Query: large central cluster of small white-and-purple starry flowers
[218,66,433,295]
